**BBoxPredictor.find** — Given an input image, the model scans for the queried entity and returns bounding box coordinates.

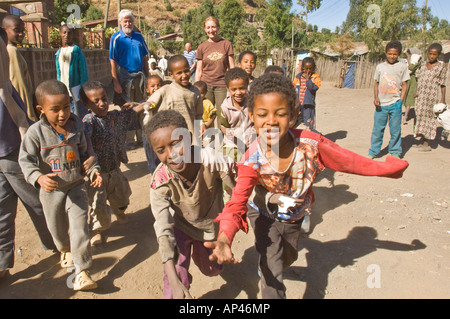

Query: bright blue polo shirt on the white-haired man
[109,29,149,73]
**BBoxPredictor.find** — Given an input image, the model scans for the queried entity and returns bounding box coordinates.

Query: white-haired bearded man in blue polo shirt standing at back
[109,9,150,146]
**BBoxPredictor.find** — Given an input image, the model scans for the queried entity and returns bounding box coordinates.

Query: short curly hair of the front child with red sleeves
[247,73,297,112]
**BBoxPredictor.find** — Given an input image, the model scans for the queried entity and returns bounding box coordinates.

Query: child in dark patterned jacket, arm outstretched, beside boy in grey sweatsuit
[80,81,143,245]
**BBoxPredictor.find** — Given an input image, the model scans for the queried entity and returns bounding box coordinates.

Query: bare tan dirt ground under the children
[0,83,450,299]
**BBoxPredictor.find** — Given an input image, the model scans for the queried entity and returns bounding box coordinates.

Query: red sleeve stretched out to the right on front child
[318,138,409,178]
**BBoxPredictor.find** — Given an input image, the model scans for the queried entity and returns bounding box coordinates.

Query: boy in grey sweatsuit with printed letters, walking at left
[19,80,102,290]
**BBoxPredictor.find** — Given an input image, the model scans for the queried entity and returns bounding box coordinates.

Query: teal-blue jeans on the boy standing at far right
[369,100,403,156]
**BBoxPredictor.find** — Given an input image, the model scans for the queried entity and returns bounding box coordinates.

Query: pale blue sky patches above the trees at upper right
[292,0,450,31]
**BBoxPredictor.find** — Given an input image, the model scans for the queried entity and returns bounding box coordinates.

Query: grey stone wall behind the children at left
[19,48,112,88]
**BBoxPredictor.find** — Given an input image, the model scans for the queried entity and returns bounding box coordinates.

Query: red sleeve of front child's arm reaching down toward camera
[214,164,258,244]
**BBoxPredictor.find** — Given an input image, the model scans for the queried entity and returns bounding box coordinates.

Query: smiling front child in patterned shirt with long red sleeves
[205,74,408,298]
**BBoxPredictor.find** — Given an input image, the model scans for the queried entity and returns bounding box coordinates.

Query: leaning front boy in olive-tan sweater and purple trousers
[144,110,235,299]
